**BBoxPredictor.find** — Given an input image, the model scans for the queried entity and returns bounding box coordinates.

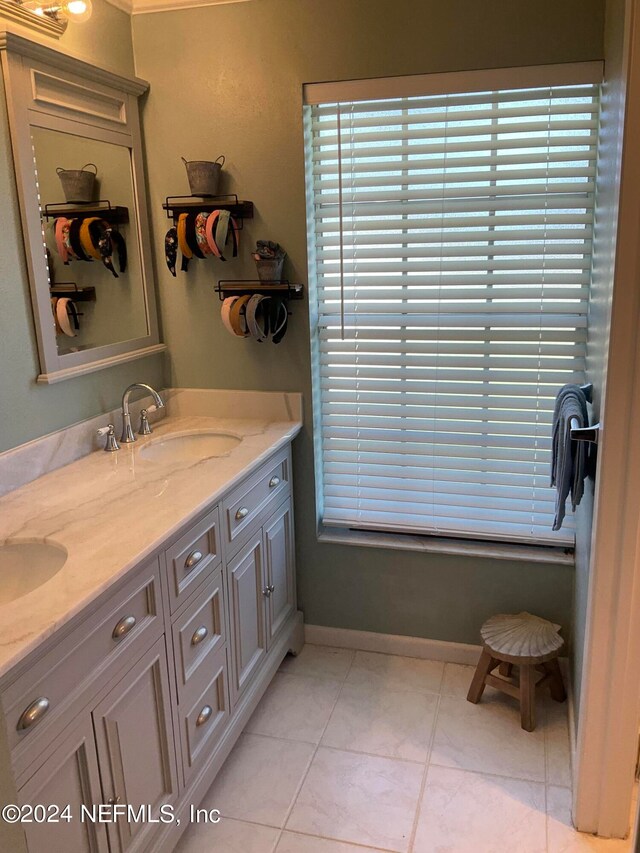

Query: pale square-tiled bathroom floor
[176,645,630,853]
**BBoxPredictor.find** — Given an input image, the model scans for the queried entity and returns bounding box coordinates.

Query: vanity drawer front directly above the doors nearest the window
[222,448,291,544]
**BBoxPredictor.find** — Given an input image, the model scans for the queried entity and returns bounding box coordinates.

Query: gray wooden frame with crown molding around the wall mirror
[0,31,166,383]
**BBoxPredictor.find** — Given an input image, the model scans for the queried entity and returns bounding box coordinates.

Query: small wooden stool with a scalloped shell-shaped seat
[467,613,567,732]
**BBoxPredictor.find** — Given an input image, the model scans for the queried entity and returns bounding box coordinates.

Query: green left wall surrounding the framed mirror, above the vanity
[0,0,164,451]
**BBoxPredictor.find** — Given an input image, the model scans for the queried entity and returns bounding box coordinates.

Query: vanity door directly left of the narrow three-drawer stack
[93,639,178,853]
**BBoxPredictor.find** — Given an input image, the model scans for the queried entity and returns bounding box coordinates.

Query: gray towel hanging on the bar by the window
[551,385,589,530]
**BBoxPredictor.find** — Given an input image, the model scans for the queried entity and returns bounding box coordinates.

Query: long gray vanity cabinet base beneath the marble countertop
[0,447,303,853]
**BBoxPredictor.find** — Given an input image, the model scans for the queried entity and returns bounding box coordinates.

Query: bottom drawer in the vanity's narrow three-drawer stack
[179,647,229,785]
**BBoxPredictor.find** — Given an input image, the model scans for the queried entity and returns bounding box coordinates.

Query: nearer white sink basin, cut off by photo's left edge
[0,542,67,604]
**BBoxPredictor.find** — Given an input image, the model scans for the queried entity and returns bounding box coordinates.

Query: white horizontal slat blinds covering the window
[306,68,599,544]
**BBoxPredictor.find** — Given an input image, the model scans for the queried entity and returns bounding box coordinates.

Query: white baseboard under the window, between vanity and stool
[304,624,482,666]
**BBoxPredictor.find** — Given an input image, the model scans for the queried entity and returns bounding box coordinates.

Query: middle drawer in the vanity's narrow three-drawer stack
[172,567,227,699]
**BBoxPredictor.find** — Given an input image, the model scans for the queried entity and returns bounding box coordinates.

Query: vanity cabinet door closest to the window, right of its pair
[264,498,296,647]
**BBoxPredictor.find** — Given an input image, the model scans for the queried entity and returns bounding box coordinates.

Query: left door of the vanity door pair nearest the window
[228,531,267,697]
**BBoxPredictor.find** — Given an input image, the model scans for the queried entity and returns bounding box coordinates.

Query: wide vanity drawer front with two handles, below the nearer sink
[2,560,164,774]
